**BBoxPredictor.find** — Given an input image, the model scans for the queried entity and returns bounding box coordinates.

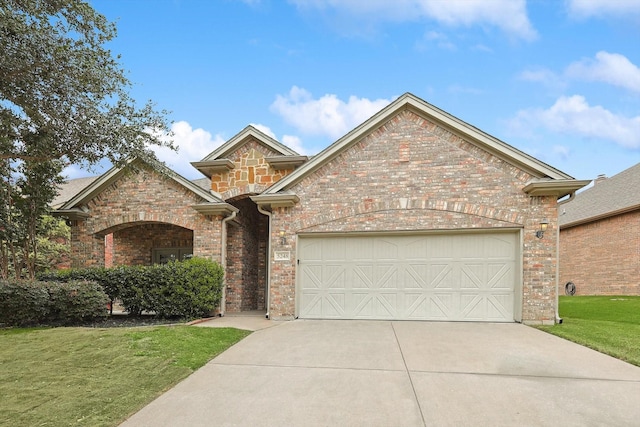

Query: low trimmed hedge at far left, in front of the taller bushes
[0,281,109,326]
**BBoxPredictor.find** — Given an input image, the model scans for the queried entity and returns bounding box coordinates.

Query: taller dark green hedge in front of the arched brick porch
[39,258,224,318]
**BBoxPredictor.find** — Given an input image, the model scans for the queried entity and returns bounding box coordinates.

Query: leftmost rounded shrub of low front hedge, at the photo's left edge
[0,280,49,326]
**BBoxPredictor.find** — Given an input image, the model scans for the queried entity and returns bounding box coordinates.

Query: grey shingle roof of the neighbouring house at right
[558,163,640,227]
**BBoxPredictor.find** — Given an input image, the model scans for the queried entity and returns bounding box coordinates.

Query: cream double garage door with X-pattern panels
[297,232,520,322]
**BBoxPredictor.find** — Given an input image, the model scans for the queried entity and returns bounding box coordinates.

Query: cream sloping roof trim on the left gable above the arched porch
[58,158,222,211]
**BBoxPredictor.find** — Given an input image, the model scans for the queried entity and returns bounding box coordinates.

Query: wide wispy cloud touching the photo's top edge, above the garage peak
[290,0,537,40]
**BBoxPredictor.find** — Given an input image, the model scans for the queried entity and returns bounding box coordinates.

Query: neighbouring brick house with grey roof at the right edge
[559,163,640,295]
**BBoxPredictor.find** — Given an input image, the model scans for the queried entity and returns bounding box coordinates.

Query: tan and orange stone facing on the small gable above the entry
[211,140,291,200]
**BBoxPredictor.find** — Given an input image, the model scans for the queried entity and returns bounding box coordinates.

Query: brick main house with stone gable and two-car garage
[58,94,587,323]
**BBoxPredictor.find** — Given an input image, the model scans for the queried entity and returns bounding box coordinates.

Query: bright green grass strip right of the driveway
[539,296,640,366]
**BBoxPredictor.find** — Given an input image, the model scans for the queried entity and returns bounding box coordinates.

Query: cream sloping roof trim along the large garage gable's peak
[264,93,573,194]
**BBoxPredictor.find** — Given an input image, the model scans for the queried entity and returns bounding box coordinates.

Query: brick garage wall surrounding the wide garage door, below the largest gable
[270,111,557,323]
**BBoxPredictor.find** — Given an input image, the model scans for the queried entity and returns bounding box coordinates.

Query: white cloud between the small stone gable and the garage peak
[270,86,391,138]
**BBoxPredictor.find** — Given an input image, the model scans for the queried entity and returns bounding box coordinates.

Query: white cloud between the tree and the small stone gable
[151,121,225,178]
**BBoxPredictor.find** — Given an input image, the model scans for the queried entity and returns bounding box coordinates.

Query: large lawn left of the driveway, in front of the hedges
[0,326,249,427]
